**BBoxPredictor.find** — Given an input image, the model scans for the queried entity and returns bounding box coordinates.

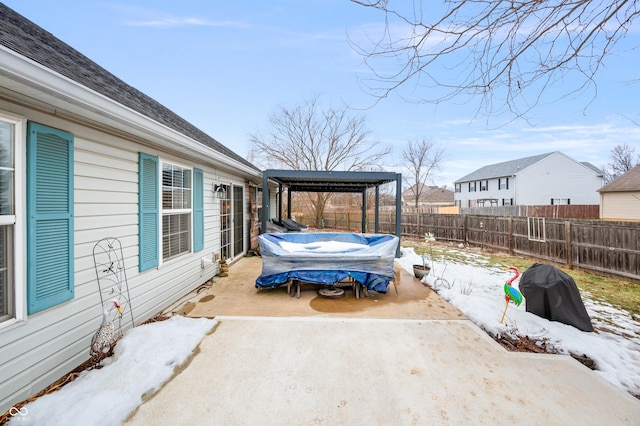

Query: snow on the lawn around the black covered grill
[396,248,640,395]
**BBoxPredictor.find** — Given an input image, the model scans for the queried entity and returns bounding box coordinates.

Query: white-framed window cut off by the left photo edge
[0,111,26,326]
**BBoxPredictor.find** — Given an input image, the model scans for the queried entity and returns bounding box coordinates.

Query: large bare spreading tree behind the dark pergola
[250,96,390,226]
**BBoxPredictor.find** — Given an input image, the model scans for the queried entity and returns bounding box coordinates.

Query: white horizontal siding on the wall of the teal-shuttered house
[0,112,229,410]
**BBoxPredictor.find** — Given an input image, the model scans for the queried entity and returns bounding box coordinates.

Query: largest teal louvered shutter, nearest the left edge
[27,123,74,314]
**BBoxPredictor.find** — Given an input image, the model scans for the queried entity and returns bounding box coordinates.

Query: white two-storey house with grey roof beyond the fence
[454,151,603,207]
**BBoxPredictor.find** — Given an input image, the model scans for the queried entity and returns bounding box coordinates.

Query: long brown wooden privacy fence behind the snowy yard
[300,213,640,280]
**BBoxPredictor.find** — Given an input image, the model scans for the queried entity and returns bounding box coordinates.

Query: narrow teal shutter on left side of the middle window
[138,152,160,272]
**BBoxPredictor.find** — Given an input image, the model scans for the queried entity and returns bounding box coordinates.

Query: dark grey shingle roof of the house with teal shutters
[0,3,259,171]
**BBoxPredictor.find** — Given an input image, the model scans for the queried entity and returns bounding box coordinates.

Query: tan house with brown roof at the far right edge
[598,164,640,221]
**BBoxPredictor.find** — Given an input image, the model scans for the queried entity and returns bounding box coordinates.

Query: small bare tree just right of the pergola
[402,139,444,208]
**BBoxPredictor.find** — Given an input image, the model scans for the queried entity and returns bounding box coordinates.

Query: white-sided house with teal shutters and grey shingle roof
[0,3,262,412]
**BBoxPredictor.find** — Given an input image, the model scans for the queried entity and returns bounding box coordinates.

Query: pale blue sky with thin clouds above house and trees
[4,0,640,186]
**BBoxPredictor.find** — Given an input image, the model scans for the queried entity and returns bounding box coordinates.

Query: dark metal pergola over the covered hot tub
[260,169,402,238]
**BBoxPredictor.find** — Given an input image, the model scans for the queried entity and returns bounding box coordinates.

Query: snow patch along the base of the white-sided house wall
[9,316,217,426]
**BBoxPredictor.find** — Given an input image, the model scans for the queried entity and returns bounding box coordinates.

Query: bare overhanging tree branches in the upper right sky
[351,0,640,116]
